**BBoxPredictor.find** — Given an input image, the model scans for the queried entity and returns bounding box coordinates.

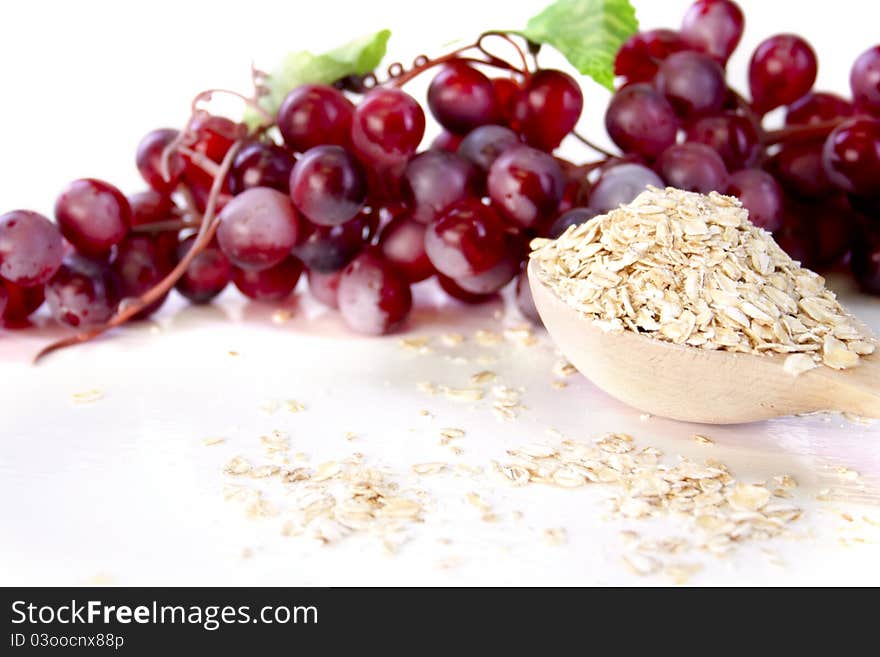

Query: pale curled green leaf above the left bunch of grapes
[244,30,391,125]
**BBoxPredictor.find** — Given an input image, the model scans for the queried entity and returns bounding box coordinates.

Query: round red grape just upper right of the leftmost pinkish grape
[55,178,131,257]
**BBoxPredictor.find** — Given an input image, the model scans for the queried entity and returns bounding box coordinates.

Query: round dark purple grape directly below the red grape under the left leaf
[290,146,367,226]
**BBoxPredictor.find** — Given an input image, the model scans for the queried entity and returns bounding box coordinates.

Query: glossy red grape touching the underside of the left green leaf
[278,84,354,153]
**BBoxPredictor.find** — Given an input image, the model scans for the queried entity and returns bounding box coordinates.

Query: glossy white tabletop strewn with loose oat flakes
[0,274,880,585]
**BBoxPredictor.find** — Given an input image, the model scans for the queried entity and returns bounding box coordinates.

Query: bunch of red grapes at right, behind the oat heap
[612,0,880,294]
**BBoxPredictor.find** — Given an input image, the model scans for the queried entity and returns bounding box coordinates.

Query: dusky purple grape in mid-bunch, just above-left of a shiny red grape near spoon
[403,150,480,224]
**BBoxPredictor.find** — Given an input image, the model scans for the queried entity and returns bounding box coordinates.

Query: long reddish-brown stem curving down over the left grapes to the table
[34,139,244,364]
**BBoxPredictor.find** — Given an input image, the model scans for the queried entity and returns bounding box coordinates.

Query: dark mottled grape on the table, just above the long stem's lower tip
[46,255,120,327]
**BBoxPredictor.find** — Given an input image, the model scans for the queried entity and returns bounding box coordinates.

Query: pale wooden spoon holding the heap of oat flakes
[528,261,880,424]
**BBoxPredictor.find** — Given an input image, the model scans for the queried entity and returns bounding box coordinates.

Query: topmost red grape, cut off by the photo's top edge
[681,0,745,64]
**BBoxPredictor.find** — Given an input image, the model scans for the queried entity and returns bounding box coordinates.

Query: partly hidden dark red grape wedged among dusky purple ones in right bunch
[685,112,761,171]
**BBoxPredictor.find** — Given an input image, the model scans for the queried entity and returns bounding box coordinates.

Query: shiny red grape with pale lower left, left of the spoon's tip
[425,200,506,278]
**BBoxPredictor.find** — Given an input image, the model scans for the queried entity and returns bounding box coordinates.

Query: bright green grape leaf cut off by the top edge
[521,0,639,90]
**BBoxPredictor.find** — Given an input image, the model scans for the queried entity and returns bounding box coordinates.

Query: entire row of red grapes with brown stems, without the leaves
[0,0,880,357]
